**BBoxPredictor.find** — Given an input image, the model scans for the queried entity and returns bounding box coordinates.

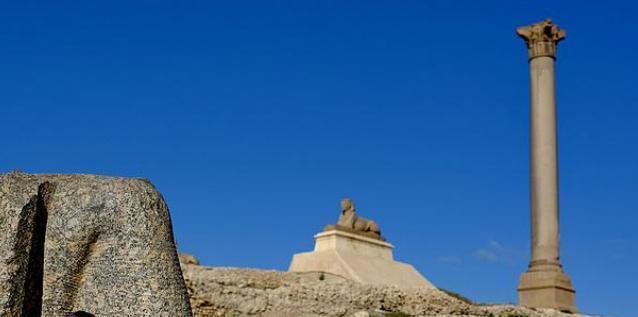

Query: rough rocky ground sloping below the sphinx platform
[181,257,574,317]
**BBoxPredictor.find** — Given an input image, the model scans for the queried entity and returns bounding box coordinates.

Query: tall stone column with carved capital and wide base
[516,19,576,312]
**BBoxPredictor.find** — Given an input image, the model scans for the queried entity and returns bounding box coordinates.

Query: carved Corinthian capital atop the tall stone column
[516,19,566,59]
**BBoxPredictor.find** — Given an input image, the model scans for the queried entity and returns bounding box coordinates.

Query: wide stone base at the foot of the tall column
[518,266,578,313]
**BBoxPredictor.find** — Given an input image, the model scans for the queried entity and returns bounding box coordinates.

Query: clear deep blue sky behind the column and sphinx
[0,0,638,317]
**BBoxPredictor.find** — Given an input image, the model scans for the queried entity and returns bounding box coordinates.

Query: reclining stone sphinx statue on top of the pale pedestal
[325,198,385,241]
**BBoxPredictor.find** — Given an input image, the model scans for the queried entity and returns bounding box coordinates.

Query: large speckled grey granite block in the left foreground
[0,172,192,317]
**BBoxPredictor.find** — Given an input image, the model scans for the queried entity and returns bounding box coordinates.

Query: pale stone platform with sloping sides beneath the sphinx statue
[289,230,435,289]
